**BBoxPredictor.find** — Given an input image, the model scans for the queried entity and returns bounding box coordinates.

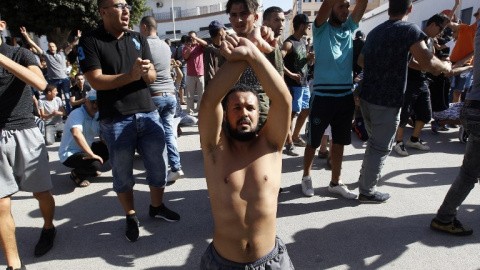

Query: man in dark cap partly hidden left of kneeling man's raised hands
[203,20,227,87]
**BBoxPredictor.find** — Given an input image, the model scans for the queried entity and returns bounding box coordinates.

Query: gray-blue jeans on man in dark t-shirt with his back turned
[358,99,400,196]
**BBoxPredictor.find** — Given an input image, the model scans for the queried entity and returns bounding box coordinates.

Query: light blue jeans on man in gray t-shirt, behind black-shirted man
[152,94,182,172]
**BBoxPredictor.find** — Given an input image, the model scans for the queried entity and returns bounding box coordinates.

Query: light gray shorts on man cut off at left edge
[0,127,52,198]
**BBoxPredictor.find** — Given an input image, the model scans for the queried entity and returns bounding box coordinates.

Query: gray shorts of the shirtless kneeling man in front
[200,236,295,270]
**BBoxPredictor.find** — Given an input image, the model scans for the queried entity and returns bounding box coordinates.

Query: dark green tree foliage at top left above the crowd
[0,0,148,47]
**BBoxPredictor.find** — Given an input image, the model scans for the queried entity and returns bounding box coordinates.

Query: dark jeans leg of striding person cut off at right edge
[437,101,480,222]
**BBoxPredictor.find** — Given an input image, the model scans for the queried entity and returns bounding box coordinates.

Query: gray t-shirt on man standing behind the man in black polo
[147,36,175,94]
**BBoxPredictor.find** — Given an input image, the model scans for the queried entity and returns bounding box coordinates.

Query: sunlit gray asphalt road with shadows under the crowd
[0,123,480,269]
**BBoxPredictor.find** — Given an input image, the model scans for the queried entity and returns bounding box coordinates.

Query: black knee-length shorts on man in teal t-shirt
[308,89,355,148]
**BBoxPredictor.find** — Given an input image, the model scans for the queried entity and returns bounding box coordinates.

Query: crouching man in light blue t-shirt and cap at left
[58,90,108,187]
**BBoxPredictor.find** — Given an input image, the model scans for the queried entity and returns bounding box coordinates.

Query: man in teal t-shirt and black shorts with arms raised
[302,0,368,199]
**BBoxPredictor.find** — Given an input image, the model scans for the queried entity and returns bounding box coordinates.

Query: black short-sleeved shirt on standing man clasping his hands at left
[78,27,156,119]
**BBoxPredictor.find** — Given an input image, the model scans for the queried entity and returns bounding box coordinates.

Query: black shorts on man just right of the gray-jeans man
[399,85,432,127]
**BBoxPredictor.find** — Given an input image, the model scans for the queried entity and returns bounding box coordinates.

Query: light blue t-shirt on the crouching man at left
[58,105,100,163]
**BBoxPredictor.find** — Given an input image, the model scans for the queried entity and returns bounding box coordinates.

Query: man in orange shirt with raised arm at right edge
[448,0,480,102]
